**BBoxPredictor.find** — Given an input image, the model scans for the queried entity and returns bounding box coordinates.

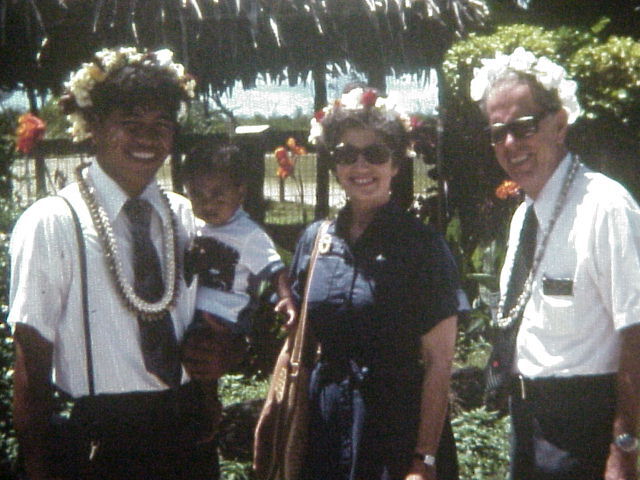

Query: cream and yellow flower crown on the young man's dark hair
[65,47,196,142]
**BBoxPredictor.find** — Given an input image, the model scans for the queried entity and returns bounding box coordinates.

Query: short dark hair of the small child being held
[181,144,247,185]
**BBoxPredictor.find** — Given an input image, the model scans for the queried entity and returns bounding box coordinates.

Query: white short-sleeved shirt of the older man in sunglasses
[500,155,640,377]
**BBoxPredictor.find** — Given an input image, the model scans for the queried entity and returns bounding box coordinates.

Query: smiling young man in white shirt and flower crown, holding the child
[9,48,230,480]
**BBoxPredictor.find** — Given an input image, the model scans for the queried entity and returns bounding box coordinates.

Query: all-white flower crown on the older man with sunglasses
[470,47,582,124]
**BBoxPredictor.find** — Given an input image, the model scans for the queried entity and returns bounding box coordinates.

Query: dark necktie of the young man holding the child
[123,198,182,387]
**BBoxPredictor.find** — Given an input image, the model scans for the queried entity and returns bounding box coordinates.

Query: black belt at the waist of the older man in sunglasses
[511,373,616,400]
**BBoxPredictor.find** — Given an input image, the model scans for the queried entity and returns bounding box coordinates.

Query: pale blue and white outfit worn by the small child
[196,208,284,334]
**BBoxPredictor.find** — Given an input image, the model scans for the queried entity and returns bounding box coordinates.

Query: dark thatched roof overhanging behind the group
[0,0,488,97]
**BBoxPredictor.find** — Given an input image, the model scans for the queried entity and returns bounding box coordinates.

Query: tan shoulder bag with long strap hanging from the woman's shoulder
[253,220,330,480]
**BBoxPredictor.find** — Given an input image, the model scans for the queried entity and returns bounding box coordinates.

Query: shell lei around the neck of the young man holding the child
[75,163,180,320]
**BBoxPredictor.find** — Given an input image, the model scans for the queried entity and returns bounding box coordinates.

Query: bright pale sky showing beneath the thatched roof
[0,68,438,117]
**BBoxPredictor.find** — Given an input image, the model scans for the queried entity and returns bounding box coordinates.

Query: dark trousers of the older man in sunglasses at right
[510,375,616,480]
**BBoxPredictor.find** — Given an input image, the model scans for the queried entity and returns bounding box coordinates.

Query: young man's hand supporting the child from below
[182,312,246,382]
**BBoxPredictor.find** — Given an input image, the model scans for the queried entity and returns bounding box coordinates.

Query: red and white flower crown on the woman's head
[309,87,415,155]
